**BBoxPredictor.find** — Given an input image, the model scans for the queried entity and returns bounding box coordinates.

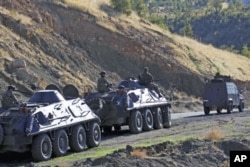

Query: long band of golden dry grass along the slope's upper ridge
[65,0,250,81]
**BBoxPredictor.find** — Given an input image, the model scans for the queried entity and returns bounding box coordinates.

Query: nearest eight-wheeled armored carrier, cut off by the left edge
[0,85,101,161]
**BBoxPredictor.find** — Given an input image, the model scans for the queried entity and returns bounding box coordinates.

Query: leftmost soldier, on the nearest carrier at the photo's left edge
[2,85,18,109]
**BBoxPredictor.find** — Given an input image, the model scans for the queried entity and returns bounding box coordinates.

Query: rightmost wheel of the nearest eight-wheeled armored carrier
[87,122,101,148]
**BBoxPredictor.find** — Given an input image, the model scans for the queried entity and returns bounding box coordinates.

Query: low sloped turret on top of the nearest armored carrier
[27,91,65,104]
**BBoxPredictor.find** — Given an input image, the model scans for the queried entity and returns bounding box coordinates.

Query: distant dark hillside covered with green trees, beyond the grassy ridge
[147,0,250,52]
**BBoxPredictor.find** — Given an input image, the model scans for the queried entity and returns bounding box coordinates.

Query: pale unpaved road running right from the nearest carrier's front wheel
[98,110,250,147]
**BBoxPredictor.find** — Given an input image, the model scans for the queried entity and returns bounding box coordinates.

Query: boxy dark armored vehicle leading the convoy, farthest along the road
[203,74,244,115]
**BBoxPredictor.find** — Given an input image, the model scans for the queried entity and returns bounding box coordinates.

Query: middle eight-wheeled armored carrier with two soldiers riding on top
[84,78,171,134]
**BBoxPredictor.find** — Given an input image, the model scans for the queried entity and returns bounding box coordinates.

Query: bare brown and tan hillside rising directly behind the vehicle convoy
[0,0,250,103]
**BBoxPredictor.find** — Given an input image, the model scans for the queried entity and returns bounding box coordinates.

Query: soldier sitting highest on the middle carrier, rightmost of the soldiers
[139,67,162,98]
